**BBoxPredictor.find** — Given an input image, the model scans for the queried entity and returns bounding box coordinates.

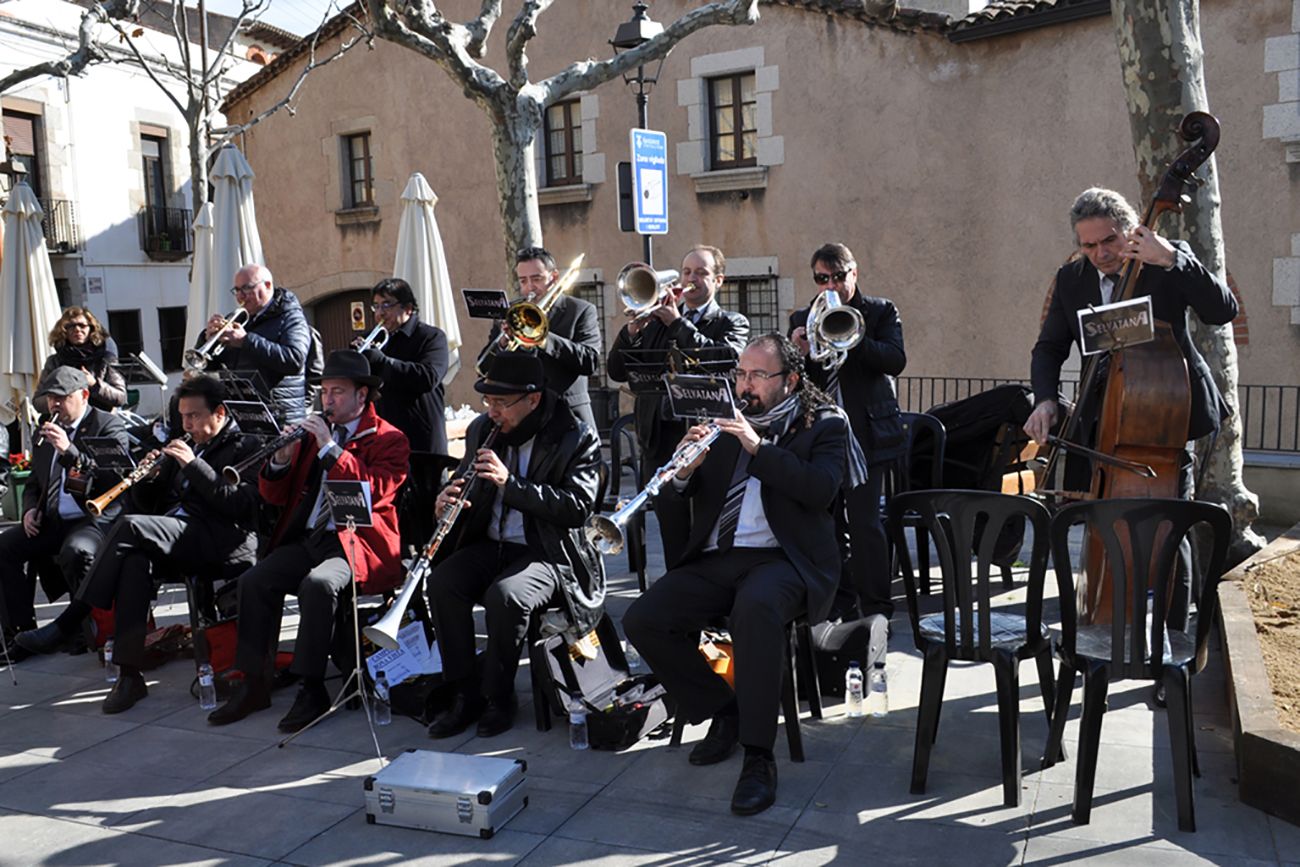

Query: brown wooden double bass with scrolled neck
[1044,112,1219,624]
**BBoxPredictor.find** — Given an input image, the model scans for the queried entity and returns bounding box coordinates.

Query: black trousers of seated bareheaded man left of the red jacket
[78,515,252,668]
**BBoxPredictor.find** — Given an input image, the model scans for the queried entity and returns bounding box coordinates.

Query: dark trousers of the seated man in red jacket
[235,530,352,679]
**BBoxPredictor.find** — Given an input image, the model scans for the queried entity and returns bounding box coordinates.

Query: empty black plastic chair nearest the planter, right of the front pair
[1043,499,1232,831]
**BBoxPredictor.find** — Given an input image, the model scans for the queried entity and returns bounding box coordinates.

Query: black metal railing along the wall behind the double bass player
[898,376,1300,452]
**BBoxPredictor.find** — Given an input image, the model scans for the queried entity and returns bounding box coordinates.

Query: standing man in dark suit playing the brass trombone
[480,247,603,430]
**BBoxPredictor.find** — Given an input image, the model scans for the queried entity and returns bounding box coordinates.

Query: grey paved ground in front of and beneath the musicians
[0,514,1300,867]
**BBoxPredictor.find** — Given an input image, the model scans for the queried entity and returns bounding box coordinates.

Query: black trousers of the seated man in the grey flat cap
[0,515,108,632]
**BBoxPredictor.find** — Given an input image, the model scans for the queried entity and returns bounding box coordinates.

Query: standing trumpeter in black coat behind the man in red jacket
[363,277,449,455]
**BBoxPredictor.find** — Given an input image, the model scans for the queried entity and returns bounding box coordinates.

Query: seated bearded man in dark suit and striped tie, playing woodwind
[623,334,850,815]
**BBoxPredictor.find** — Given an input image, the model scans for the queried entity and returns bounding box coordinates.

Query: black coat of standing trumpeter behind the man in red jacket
[365,316,449,455]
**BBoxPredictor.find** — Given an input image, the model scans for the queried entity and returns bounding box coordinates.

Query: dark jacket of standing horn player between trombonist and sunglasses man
[606,304,749,457]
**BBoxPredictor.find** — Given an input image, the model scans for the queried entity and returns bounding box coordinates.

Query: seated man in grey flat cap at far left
[0,367,129,656]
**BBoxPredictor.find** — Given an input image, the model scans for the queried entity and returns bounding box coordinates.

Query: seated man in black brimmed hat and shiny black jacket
[428,352,605,738]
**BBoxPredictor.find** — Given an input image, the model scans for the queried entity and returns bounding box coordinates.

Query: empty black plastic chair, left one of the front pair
[889,490,1054,806]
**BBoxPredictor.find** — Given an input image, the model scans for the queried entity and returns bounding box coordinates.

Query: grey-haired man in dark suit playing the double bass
[1024,187,1236,629]
